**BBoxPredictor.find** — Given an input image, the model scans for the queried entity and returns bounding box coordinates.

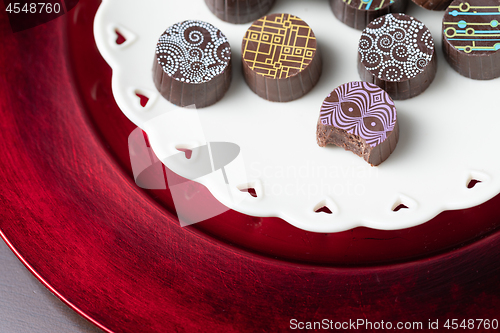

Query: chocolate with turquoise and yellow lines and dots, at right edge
[443,0,500,80]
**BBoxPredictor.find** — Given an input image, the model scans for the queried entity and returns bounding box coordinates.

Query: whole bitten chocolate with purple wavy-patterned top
[316,82,399,165]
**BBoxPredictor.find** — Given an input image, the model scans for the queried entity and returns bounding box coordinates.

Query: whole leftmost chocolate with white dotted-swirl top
[153,21,231,108]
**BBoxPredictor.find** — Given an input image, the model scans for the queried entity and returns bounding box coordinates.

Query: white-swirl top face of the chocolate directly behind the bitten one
[358,14,434,82]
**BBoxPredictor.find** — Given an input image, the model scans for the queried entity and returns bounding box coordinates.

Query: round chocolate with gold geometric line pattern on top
[241,14,322,102]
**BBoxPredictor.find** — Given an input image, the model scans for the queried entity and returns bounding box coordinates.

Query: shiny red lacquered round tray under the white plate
[0,0,500,332]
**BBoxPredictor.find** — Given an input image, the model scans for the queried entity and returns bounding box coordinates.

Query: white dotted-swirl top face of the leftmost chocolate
[156,20,231,84]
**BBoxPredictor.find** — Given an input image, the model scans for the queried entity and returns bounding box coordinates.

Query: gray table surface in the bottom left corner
[0,238,103,333]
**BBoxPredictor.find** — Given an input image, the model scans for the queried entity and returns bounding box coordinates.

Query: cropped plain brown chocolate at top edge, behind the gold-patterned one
[205,0,275,24]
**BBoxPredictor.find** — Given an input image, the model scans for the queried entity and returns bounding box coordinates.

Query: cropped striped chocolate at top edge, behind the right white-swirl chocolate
[330,0,408,30]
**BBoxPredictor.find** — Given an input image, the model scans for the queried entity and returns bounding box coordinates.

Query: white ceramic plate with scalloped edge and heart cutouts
[94,0,500,232]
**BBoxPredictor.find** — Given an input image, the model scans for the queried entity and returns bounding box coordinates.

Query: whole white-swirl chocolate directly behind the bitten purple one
[358,14,437,99]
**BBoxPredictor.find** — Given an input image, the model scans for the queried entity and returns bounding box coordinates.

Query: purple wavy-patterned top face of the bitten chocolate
[320,82,396,147]
